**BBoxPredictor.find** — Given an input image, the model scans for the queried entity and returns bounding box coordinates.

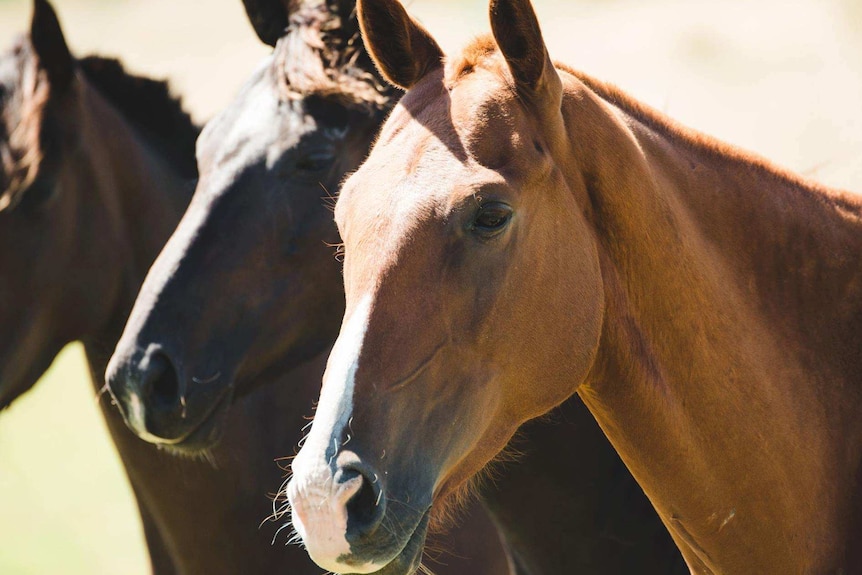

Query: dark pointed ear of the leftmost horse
[30,0,75,90]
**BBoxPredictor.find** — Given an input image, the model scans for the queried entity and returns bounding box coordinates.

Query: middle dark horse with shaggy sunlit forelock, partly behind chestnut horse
[108,2,685,575]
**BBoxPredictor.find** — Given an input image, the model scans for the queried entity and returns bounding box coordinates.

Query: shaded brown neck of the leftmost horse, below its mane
[75,82,193,383]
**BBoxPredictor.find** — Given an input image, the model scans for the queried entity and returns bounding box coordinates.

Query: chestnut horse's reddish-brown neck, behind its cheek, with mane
[564,70,862,573]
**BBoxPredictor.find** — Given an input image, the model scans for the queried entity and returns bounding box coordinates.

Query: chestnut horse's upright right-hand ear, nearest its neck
[490,0,560,99]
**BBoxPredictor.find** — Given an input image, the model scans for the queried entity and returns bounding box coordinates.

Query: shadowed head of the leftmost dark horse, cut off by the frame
[0,2,117,408]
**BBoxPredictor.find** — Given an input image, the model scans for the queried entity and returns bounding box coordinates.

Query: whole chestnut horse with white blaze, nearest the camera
[288,0,862,575]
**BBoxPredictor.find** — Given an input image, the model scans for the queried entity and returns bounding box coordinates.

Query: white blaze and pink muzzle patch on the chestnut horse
[287,294,384,573]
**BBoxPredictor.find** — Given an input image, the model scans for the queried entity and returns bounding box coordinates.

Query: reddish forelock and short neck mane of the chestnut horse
[446,34,862,214]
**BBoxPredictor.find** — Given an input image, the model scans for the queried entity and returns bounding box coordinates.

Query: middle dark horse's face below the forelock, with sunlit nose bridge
[108,51,375,451]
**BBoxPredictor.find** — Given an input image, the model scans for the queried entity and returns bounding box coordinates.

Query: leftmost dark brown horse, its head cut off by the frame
[0,0,364,575]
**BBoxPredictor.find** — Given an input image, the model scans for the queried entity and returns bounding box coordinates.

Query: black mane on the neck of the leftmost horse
[78,56,200,178]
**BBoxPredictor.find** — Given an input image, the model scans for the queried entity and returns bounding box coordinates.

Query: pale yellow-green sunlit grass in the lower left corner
[0,345,148,575]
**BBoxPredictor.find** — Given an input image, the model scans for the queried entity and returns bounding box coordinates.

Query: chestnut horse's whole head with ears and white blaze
[288,0,603,575]
